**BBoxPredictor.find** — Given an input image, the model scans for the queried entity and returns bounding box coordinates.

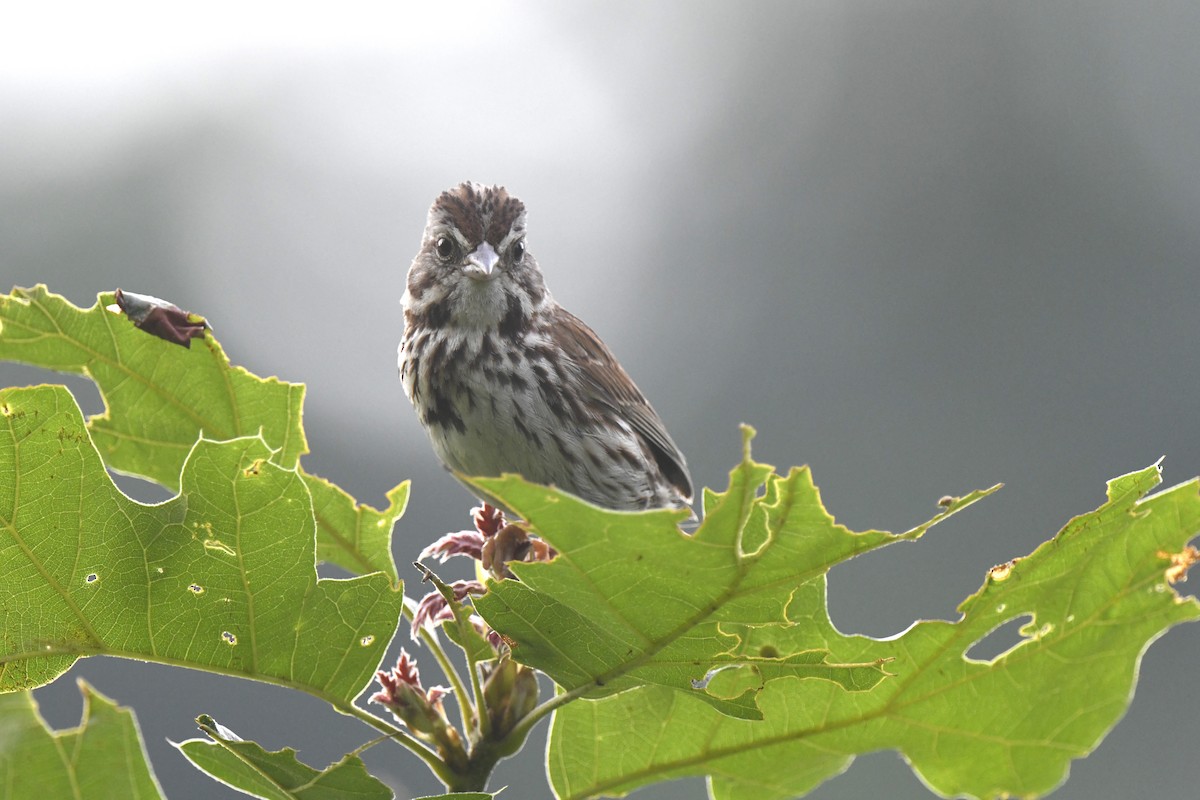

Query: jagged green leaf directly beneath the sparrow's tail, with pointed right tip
[473,429,991,718]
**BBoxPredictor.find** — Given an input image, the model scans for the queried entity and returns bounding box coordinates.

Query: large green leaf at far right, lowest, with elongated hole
[548,467,1200,800]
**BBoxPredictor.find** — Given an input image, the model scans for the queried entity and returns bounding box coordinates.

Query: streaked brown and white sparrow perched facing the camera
[400,184,692,510]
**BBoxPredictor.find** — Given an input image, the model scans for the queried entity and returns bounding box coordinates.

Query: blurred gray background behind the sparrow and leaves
[0,0,1200,800]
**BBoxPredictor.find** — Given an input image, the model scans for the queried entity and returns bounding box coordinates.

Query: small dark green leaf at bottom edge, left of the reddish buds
[173,715,394,800]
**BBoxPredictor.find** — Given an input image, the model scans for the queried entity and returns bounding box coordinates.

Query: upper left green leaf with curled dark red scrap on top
[0,285,408,582]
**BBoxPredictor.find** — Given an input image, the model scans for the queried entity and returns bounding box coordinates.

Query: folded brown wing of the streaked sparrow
[550,307,692,503]
